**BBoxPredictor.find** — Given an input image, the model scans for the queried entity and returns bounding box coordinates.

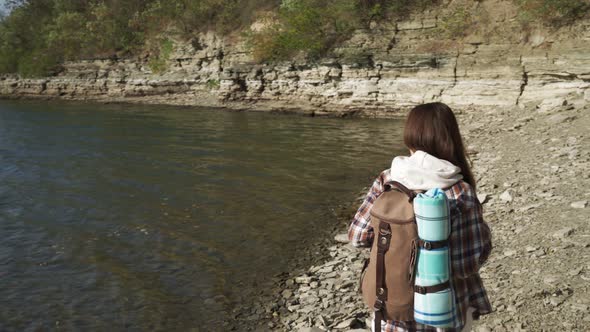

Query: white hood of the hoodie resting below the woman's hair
[390,150,463,190]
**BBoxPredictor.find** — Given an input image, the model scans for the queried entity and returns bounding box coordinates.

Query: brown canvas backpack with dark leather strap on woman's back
[361,182,434,331]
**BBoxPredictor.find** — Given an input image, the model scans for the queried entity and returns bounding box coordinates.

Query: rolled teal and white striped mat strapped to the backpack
[414,189,455,328]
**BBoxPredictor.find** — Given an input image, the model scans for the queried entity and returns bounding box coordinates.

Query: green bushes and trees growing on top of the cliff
[0,0,590,77]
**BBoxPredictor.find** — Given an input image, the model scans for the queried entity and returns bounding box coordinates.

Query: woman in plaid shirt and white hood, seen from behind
[348,103,492,332]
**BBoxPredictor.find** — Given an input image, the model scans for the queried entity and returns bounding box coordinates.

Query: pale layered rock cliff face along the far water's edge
[0,1,590,116]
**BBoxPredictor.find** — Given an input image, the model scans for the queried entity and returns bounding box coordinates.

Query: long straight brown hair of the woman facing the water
[404,103,476,190]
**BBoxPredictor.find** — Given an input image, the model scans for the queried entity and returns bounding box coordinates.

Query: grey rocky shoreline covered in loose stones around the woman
[250,99,590,332]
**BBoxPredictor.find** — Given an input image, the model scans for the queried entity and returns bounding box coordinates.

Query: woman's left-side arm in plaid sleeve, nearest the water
[348,170,389,247]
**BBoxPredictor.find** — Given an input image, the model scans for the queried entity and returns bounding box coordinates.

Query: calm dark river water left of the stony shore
[0,101,404,331]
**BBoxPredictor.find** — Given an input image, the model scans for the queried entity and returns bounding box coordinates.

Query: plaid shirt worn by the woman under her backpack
[348,169,492,332]
